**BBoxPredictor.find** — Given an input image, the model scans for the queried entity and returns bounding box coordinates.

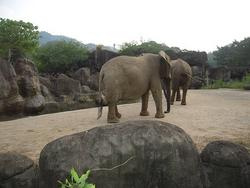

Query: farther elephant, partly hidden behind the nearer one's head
[170,59,192,105]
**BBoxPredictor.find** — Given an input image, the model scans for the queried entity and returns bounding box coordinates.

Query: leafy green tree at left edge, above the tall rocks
[0,18,39,59]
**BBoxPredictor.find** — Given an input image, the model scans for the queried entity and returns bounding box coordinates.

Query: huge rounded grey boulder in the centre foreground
[39,121,203,188]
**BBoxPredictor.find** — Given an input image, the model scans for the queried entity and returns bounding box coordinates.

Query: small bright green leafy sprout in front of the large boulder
[58,168,95,188]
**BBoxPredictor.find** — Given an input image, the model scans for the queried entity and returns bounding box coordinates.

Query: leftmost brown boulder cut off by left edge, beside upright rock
[0,59,24,114]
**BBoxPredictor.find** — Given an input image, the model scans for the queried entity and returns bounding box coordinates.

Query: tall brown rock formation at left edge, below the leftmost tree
[0,59,44,115]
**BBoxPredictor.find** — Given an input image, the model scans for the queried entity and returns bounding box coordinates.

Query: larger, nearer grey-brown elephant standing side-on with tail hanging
[98,51,170,123]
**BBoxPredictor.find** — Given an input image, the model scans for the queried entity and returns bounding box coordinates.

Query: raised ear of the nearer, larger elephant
[159,51,171,79]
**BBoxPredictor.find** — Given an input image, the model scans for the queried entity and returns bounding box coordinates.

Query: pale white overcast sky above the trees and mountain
[0,0,250,52]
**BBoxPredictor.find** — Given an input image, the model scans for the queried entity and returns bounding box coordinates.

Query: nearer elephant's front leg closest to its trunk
[151,84,164,118]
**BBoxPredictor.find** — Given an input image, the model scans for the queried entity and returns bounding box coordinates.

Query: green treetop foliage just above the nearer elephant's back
[120,41,170,56]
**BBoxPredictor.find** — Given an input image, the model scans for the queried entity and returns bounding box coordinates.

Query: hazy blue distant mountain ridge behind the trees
[39,31,118,52]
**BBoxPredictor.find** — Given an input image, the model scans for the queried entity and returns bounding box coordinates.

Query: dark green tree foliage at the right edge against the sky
[214,38,250,67]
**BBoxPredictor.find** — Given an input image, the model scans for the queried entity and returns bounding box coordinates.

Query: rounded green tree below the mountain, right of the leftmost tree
[35,41,89,73]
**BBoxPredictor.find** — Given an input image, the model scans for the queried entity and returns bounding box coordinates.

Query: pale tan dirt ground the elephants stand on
[0,89,250,162]
